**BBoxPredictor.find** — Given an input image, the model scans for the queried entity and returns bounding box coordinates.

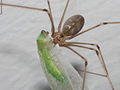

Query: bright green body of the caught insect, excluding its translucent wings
[37,31,66,83]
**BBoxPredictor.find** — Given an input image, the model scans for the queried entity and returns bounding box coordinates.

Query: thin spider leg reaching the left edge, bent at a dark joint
[0,3,54,34]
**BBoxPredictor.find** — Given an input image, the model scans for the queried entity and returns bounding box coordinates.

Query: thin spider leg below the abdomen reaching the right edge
[69,22,120,39]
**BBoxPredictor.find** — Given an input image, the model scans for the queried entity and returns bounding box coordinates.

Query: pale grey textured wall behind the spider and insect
[0,0,120,90]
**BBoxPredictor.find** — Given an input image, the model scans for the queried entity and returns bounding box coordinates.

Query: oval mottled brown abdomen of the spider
[62,15,84,36]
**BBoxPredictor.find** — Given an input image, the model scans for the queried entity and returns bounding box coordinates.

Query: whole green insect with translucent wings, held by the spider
[37,30,87,90]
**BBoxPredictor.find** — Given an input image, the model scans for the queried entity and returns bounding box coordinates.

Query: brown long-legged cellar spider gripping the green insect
[0,0,120,90]
